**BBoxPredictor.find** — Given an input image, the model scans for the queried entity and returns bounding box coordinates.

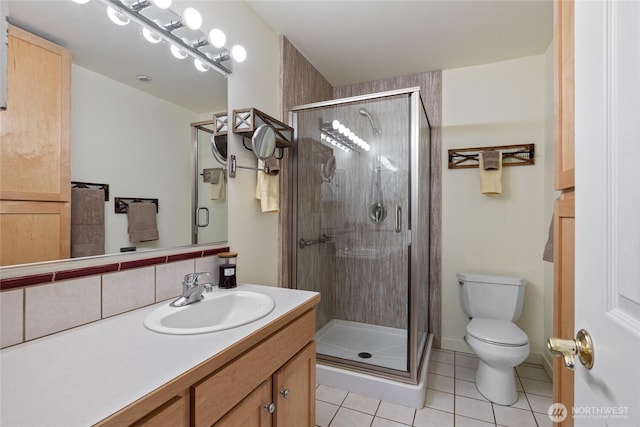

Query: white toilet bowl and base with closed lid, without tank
[464,318,530,405]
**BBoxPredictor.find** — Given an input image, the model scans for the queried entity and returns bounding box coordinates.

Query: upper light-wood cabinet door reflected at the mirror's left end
[0,26,71,202]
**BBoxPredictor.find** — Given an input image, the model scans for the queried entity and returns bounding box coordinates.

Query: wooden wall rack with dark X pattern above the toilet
[449,144,536,169]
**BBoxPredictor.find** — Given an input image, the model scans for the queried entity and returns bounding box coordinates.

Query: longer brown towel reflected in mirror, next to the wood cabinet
[71,188,104,258]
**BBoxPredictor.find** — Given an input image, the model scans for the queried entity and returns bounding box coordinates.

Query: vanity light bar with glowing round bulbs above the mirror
[81,0,247,76]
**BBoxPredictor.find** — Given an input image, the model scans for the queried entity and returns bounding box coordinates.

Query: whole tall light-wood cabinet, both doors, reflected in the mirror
[0,26,71,265]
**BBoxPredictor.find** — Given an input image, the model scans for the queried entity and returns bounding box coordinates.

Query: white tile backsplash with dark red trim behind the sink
[0,248,228,348]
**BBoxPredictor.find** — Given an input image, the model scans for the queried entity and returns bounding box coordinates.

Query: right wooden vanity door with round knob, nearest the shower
[273,341,316,427]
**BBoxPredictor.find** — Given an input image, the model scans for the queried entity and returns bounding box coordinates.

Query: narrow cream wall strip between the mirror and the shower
[225,2,280,286]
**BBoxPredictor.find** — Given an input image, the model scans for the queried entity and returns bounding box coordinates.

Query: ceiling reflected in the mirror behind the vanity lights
[1,0,229,113]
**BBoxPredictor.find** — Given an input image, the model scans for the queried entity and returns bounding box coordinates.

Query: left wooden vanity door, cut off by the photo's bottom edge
[214,380,272,427]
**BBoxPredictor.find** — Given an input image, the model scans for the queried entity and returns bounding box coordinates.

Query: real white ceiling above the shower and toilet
[247,0,553,86]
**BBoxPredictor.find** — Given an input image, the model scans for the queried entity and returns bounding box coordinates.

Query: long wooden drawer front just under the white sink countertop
[192,310,315,426]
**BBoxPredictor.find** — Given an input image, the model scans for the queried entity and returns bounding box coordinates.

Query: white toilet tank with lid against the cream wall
[457,273,527,322]
